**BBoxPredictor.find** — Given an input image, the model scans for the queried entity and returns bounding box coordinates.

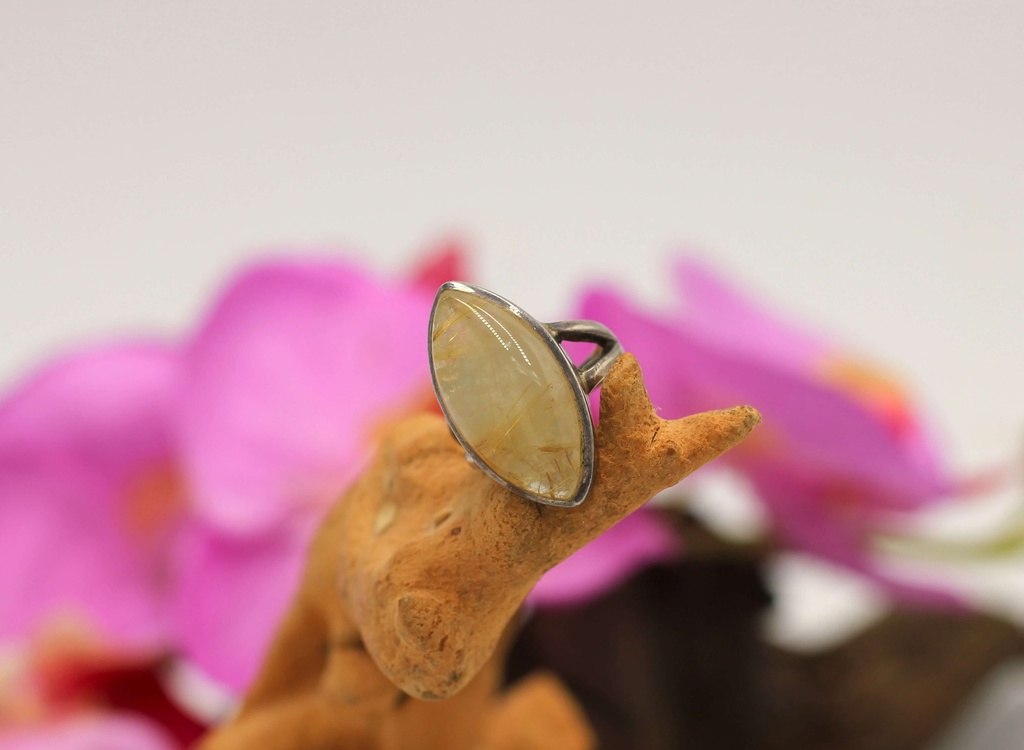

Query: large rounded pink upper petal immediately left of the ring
[181,259,431,534]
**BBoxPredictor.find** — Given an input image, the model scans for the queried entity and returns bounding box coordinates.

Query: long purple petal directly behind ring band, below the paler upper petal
[582,290,951,508]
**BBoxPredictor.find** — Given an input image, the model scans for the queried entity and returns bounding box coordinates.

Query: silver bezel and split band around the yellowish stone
[427,281,623,508]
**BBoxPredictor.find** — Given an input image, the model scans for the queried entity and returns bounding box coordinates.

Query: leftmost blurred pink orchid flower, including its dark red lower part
[0,342,202,750]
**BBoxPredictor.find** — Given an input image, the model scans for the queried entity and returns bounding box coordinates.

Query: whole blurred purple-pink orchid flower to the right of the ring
[580,261,956,605]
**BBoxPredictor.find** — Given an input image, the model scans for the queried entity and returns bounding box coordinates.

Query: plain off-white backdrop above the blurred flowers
[0,0,1024,745]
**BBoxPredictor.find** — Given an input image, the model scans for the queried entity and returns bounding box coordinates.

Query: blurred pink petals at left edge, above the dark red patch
[0,344,177,647]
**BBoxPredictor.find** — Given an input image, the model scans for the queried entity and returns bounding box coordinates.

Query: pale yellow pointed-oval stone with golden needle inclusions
[430,289,589,502]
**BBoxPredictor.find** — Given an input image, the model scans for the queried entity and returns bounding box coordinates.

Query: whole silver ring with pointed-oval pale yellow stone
[428,282,623,507]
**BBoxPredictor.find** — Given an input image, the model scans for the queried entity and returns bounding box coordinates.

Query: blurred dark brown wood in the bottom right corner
[764,609,1024,750]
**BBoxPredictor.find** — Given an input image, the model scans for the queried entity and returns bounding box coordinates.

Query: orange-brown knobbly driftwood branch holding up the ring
[204,355,760,750]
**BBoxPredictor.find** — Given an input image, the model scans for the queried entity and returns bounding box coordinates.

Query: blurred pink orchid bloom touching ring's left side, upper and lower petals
[176,253,454,689]
